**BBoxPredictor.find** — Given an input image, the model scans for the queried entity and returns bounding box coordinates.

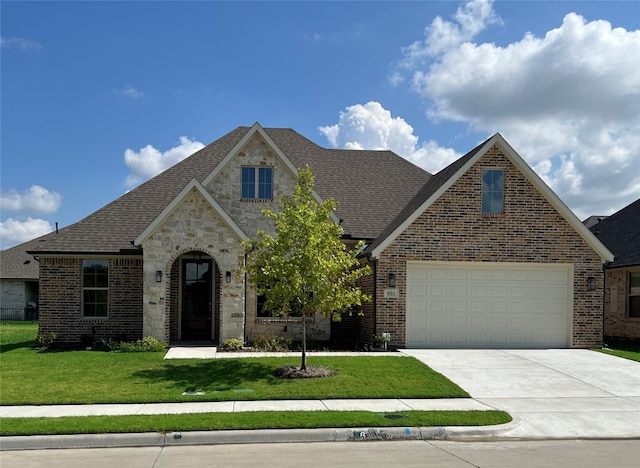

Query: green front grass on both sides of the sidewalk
[0,322,511,436]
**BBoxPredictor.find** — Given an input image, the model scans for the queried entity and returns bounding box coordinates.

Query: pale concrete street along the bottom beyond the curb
[0,440,640,468]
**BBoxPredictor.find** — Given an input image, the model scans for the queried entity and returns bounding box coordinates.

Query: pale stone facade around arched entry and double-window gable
[142,135,302,343]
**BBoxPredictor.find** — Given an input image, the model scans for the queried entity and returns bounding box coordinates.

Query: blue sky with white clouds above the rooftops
[0,0,640,249]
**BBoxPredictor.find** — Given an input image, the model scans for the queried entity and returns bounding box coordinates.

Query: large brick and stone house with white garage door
[30,123,613,347]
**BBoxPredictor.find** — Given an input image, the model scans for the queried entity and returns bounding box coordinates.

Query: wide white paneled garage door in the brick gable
[407,262,573,348]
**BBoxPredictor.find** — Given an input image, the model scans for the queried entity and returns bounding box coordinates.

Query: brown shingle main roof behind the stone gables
[30,127,430,254]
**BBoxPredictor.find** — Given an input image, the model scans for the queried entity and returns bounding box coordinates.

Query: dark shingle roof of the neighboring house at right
[590,199,640,268]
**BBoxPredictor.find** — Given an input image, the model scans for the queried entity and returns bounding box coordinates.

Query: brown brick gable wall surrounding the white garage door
[367,145,603,347]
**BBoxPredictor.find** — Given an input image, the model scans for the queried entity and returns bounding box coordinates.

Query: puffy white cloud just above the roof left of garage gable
[319,101,461,173]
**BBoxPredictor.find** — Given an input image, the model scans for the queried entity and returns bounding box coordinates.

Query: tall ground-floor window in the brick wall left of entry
[82,260,109,317]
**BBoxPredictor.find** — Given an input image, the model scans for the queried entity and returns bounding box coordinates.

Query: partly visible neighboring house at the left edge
[0,239,50,320]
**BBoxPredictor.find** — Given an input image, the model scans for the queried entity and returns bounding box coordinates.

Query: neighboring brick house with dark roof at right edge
[591,199,640,339]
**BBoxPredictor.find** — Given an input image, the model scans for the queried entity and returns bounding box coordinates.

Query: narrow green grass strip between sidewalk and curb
[0,411,511,436]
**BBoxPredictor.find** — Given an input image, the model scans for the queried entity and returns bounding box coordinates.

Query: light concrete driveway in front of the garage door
[402,349,640,438]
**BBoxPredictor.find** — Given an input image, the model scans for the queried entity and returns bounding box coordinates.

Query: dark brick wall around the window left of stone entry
[39,257,142,344]
